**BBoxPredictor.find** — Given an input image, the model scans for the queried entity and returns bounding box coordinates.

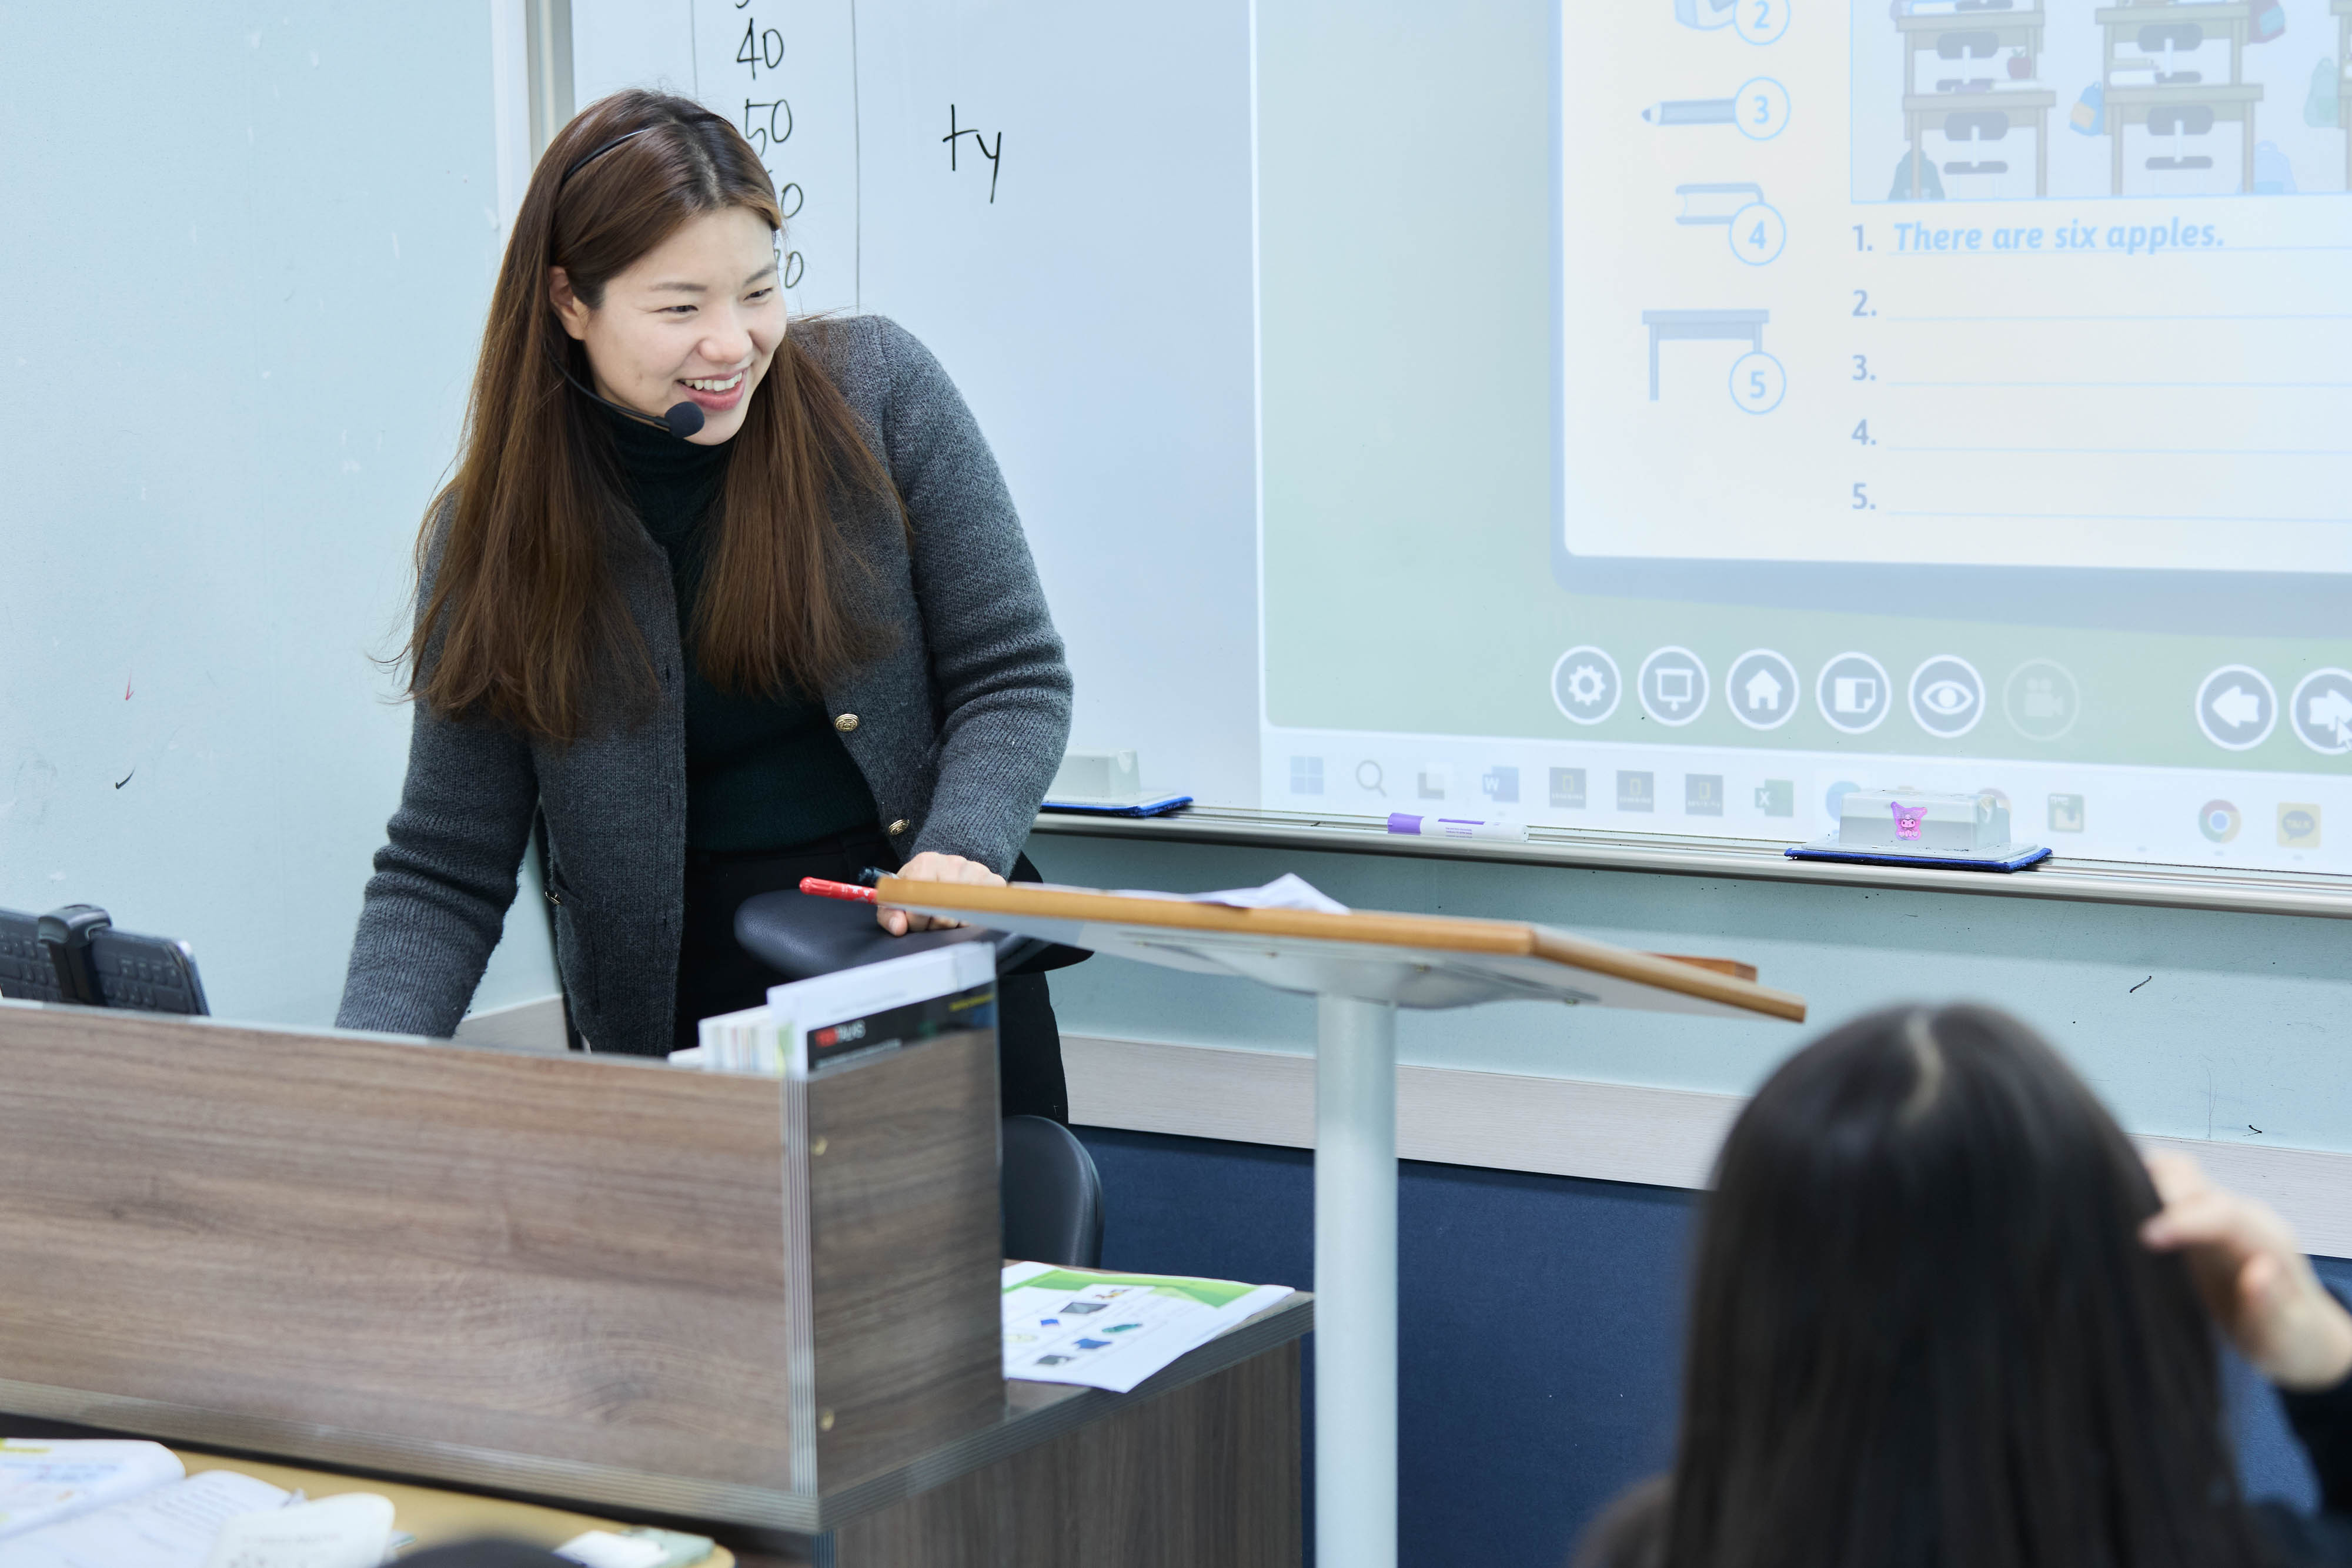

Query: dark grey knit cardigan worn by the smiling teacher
[334,315,1070,1055]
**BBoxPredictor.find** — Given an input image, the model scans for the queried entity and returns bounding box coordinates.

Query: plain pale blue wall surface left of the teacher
[0,0,553,1022]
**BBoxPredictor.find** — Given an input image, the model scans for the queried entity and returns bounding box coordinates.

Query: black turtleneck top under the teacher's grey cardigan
[600,409,875,851]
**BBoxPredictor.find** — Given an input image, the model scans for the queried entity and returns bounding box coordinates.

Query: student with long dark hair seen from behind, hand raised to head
[1576,1006,2352,1568]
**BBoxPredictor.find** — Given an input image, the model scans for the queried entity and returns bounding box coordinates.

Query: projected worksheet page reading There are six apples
[1559,0,2352,574]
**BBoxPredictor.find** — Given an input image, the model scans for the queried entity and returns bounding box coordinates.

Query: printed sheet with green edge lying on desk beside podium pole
[1004,1262,1291,1394]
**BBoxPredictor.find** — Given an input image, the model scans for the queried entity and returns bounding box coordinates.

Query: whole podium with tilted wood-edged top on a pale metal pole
[875,879,1804,1568]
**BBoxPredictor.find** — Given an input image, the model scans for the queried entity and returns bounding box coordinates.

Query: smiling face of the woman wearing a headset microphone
[548,207,783,447]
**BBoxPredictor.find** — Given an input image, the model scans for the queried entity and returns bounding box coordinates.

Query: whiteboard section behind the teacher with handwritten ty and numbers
[572,0,1258,799]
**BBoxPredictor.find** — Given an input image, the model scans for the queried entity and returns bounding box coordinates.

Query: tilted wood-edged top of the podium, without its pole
[875,877,1804,1022]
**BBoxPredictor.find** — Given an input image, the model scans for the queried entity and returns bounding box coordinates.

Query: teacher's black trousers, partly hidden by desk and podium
[677,827,1070,1121]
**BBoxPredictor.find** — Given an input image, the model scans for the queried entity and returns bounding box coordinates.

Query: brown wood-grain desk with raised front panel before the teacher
[0,1006,1317,1568]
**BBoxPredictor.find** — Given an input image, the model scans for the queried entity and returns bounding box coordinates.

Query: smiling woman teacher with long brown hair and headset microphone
[336,92,1070,1119]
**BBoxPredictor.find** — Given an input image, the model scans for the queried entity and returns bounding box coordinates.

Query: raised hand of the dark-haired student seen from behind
[2140,1154,2352,1392]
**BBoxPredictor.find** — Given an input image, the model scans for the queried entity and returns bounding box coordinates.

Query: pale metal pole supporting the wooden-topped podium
[1315,994,1397,1568]
